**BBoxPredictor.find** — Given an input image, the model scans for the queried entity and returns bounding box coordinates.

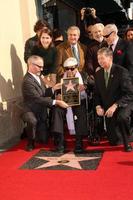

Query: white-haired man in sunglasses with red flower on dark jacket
[103,24,133,81]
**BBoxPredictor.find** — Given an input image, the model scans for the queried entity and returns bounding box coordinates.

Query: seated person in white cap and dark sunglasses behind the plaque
[51,57,88,153]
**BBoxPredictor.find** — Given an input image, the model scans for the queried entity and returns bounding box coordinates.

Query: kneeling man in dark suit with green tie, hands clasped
[95,47,133,152]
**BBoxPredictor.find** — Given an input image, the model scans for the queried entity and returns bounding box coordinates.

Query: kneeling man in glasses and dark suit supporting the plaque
[22,55,68,151]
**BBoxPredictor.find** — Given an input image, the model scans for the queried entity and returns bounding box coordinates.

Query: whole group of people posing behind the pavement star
[22,8,133,153]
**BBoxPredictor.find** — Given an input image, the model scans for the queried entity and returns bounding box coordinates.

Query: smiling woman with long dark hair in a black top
[32,28,57,87]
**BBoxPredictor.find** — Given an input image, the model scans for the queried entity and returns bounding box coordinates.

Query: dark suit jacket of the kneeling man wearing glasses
[22,72,53,114]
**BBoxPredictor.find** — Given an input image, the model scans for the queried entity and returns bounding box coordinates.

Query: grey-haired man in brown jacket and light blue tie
[57,26,86,81]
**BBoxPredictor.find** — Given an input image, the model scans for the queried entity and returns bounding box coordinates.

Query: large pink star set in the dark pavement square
[35,152,100,169]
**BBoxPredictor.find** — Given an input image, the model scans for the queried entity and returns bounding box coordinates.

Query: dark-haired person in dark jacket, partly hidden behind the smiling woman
[24,19,50,63]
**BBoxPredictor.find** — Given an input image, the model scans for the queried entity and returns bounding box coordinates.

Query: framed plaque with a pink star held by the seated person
[61,77,80,106]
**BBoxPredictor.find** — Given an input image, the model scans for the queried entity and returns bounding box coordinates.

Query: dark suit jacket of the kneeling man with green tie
[95,64,133,110]
